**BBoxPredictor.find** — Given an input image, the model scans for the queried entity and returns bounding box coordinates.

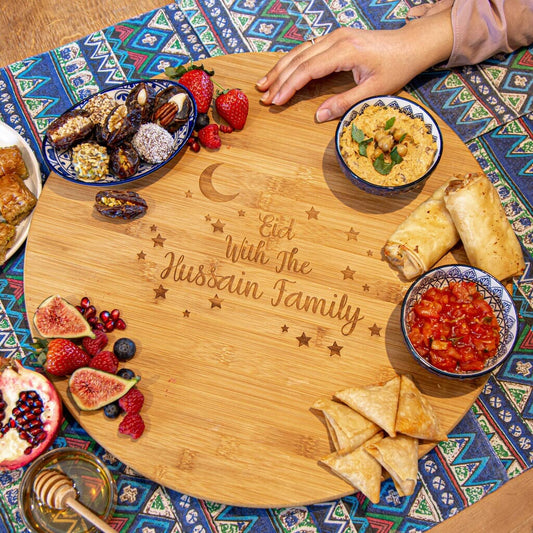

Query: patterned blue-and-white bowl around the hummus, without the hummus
[335,96,442,196]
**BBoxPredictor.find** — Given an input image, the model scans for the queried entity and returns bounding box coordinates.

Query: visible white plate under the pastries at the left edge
[0,122,42,261]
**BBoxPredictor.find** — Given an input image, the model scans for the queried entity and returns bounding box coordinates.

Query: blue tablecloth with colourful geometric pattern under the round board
[0,0,533,533]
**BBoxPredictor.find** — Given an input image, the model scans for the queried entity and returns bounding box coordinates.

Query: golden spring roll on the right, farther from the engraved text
[444,173,525,281]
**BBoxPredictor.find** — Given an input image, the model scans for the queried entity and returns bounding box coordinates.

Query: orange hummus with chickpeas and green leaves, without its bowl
[340,105,437,186]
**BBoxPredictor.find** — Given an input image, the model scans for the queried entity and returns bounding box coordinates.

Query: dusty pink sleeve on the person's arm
[408,0,533,68]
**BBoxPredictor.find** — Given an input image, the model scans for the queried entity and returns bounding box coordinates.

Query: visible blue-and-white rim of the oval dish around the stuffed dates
[43,79,197,187]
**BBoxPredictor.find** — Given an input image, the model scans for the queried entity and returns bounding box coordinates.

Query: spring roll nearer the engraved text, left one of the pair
[383,182,459,279]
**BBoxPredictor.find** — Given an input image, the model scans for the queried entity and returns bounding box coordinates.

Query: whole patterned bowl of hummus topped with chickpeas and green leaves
[335,96,442,196]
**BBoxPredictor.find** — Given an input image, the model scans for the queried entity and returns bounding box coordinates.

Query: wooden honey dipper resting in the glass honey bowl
[33,468,117,533]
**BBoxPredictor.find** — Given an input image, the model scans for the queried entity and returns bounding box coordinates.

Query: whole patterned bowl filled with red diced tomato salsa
[401,265,518,379]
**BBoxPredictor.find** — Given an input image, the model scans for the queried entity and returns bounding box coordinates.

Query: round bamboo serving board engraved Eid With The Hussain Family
[24,53,485,507]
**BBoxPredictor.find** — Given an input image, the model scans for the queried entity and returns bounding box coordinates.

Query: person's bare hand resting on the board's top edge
[257,11,453,122]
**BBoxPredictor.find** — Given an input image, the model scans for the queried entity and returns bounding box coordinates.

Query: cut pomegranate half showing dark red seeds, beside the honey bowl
[0,357,63,470]
